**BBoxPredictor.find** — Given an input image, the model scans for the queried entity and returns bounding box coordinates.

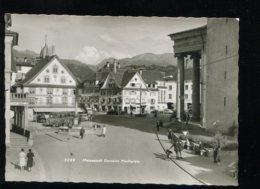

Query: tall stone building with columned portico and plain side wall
[169,18,239,130]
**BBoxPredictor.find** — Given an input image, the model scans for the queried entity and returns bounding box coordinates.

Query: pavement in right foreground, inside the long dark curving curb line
[159,134,238,186]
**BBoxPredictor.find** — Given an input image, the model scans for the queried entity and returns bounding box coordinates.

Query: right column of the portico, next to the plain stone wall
[191,53,200,121]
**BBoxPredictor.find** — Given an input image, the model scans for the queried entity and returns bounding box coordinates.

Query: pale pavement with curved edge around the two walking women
[5,148,46,181]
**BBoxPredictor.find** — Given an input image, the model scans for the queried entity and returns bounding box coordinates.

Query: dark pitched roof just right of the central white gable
[141,70,165,84]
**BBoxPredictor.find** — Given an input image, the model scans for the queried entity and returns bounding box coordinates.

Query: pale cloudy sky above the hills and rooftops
[10,14,207,65]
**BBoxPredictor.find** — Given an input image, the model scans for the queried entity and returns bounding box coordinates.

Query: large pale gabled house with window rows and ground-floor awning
[15,52,80,120]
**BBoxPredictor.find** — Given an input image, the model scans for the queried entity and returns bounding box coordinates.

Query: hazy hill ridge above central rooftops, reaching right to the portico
[97,53,177,68]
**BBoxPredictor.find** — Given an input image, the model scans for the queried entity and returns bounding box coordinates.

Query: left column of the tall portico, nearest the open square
[175,54,184,121]
